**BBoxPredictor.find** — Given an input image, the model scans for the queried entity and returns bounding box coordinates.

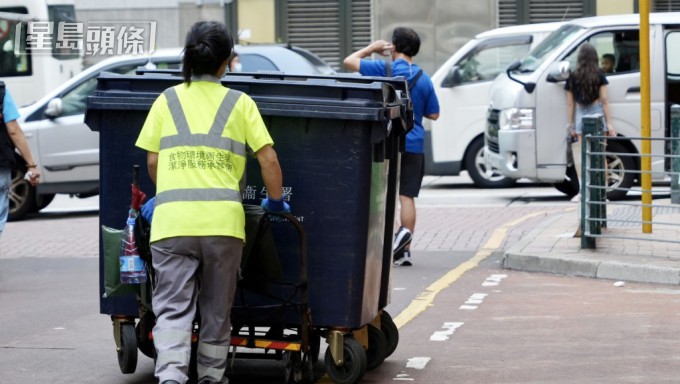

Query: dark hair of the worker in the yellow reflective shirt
[182,21,234,85]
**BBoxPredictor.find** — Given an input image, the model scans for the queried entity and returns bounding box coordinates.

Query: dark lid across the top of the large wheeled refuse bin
[85,70,413,132]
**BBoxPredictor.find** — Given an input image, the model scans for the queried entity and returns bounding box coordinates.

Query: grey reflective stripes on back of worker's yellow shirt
[156,88,246,210]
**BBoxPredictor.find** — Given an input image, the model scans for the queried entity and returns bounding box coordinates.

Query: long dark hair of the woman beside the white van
[569,43,600,105]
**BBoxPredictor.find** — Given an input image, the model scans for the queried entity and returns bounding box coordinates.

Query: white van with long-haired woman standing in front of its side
[485,13,680,199]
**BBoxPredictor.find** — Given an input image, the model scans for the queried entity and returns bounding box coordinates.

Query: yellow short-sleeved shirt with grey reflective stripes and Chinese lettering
[136,76,273,242]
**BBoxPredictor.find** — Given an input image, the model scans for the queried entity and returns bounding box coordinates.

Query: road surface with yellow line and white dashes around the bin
[0,178,680,384]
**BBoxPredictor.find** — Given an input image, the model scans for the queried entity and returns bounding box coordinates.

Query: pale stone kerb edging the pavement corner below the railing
[502,214,680,285]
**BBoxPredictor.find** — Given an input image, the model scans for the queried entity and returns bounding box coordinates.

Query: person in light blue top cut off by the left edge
[0,85,40,235]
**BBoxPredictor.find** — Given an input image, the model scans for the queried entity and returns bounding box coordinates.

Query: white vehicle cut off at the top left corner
[0,0,82,106]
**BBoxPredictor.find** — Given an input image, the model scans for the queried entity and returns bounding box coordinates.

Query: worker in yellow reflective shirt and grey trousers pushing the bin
[136,21,290,384]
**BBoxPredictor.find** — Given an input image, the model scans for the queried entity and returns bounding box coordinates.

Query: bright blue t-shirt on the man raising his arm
[359,59,439,153]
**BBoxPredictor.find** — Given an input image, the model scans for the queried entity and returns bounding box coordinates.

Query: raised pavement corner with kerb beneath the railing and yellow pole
[503,198,680,285]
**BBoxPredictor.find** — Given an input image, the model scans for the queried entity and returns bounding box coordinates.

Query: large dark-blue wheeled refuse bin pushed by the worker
[86,67,413,383]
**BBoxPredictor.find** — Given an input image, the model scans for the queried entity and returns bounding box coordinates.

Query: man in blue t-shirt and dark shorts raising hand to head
[344,27,439,266]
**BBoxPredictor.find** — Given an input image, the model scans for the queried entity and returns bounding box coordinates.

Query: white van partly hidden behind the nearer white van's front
[425,23,563,187]
